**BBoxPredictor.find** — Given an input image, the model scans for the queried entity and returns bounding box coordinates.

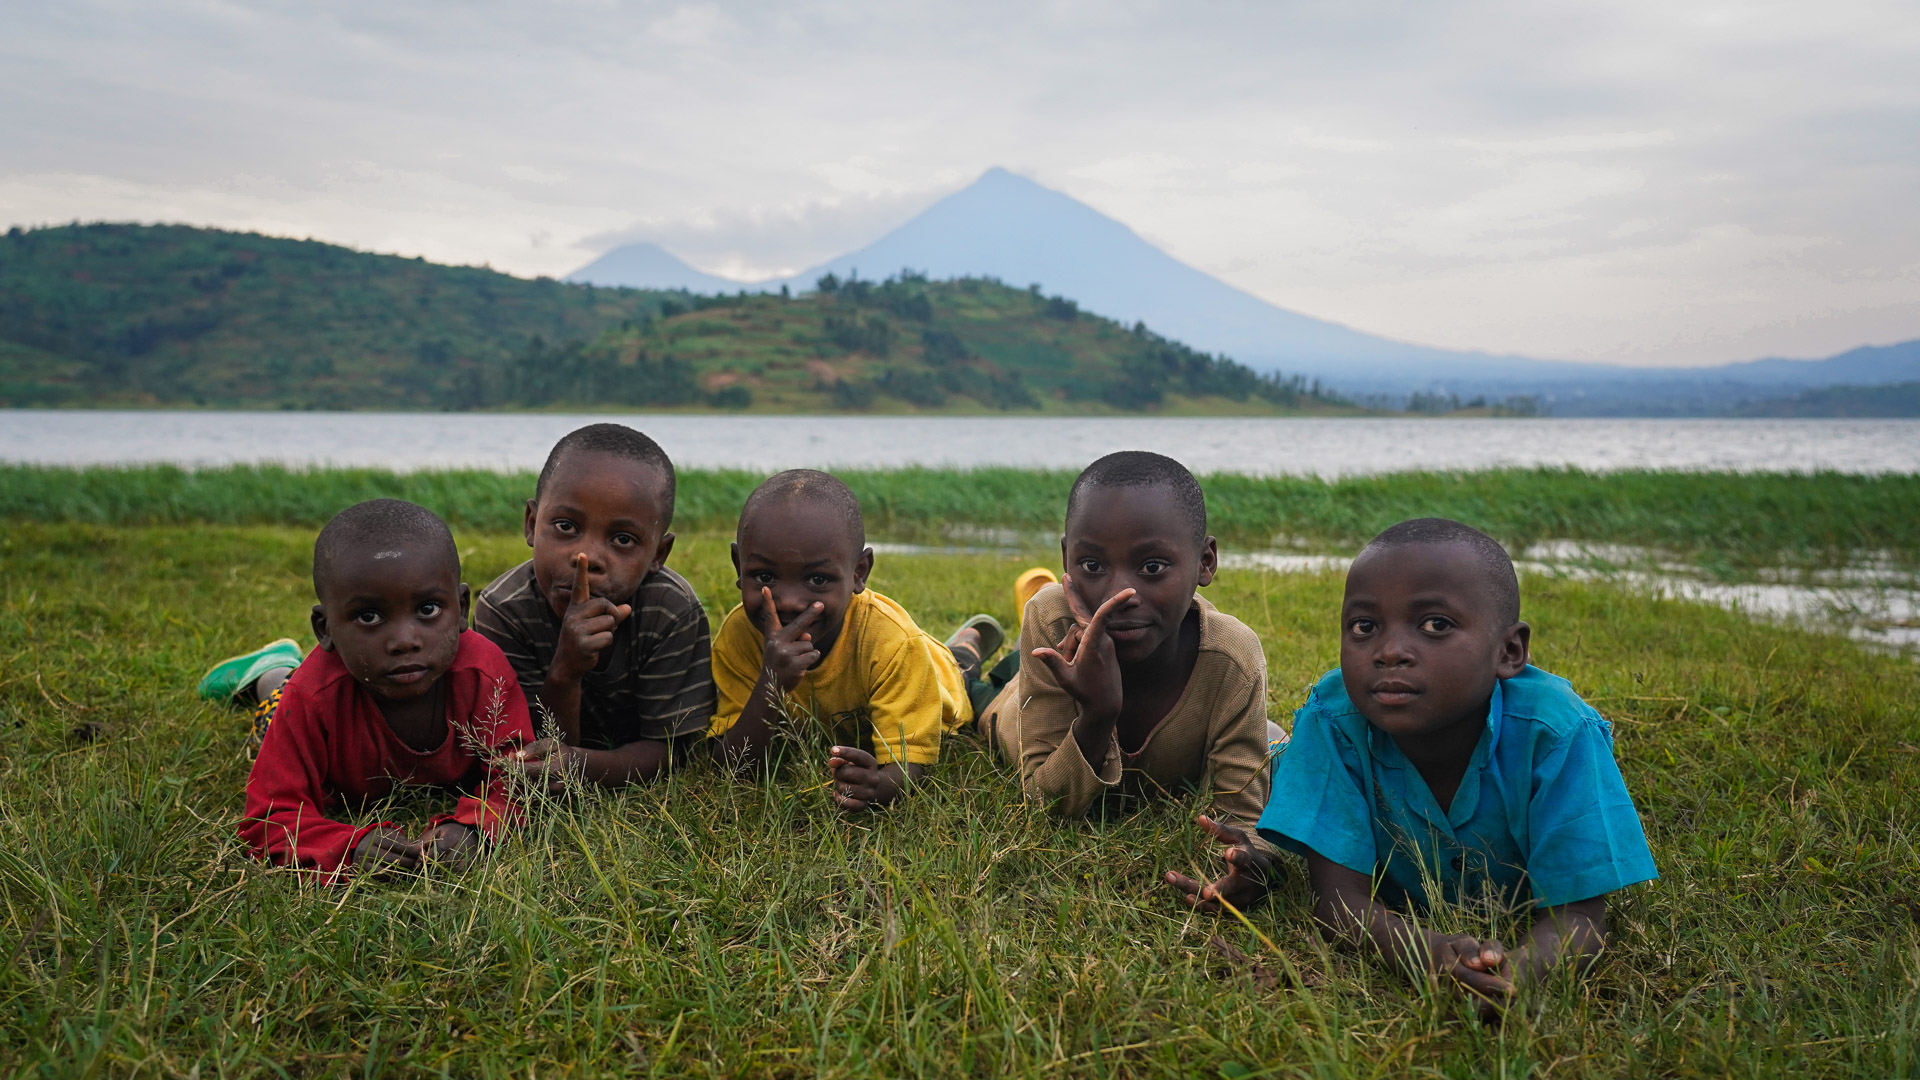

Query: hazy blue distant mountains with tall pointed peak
[568,169,1920,415]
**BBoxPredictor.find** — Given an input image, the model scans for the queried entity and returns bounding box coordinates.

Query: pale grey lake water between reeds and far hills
[0,409,1920,477]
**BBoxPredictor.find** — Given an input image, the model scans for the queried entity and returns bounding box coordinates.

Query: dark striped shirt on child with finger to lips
[474,559,714,749]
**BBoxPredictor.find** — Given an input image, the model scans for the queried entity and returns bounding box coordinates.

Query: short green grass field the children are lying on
[0,518,1920,1078]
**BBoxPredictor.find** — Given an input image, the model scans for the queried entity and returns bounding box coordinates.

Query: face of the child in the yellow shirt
[733,500,874,659]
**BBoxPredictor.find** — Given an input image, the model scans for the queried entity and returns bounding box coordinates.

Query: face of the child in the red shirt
[313,544,467,701]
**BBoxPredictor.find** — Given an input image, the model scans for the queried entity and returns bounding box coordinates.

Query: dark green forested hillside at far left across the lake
[0,225,668,409]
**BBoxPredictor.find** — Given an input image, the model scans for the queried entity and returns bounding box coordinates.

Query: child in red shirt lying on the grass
[240,500,534,882]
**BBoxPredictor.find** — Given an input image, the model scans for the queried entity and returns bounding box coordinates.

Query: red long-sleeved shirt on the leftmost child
[240,630,534,882]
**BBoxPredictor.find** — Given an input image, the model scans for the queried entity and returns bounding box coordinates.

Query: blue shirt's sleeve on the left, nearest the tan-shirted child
[1260,688,1379,876]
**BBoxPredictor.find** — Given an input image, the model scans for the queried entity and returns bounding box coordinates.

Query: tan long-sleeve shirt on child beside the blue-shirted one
[985,584,1269,832]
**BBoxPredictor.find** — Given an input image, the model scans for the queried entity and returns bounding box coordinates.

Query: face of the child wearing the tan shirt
[1060,484,1219,663]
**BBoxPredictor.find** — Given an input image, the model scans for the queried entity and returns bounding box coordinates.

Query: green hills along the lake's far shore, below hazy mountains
[0,225,1352,413]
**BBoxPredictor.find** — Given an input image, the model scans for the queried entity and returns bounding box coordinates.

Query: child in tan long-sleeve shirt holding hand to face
[979,452,1277,911]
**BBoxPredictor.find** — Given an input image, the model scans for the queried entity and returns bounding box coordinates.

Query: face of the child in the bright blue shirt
[1340,544,1530,738]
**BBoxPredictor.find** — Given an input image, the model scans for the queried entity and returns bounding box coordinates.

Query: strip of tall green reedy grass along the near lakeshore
[0,465,1920,573]
